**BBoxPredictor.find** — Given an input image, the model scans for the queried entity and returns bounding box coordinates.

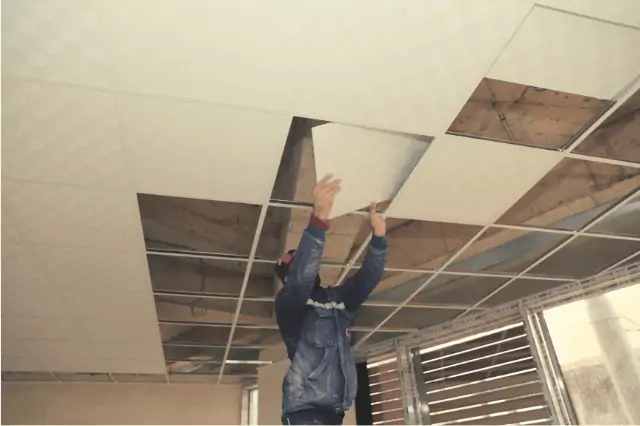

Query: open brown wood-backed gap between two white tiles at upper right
[448,78,611,149]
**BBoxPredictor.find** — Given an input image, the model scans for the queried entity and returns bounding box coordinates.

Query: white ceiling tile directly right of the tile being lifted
[387,135,562,225]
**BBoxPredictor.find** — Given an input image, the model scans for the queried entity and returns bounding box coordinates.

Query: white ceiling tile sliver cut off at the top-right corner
[536,0,640,27]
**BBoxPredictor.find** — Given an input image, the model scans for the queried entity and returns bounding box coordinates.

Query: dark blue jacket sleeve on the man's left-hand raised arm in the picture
[276,216,328,310]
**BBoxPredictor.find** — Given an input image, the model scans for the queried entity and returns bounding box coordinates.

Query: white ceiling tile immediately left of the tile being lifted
[117,96,291,204]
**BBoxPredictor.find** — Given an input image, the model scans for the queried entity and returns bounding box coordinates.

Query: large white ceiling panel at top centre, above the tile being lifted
[108,0,532,135]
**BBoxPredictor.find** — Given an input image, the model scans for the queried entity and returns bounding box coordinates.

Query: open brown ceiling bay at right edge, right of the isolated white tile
[497,158,640,230]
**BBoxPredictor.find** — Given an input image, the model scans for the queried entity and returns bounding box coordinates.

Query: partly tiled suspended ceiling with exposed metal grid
[2,0,640,382]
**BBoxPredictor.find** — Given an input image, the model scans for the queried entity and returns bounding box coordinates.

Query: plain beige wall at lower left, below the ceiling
[2,383,242,424]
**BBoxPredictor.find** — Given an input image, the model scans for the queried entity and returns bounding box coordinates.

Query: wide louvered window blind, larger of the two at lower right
[420,323,551,425]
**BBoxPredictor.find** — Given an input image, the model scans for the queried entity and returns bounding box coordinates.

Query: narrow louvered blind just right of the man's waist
[367,358,404,425]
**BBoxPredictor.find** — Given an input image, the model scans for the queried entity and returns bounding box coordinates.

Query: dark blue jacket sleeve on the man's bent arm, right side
[338,235,387,313]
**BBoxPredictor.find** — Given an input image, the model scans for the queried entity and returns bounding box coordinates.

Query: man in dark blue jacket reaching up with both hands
[276,175,387,425]
